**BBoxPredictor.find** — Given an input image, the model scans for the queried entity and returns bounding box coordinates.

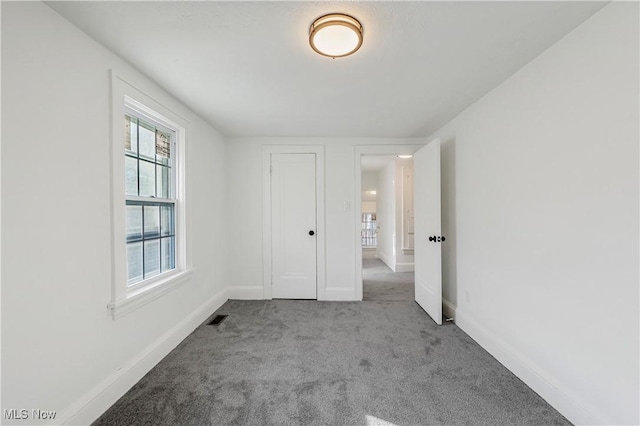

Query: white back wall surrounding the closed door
[227,138,426,300]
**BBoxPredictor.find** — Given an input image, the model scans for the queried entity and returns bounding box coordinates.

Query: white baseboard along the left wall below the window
[56,289,228,425]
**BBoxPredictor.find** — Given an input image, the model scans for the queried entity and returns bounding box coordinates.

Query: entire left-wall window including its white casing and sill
[107,72,193,319]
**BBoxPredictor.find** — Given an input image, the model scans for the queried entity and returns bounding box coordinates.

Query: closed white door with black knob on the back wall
[271,154,317,299]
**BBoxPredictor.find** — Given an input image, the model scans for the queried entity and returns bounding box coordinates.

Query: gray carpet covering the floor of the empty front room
[95,300,569,425]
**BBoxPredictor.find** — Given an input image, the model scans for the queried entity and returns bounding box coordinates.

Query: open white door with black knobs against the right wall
[413,139,443,325]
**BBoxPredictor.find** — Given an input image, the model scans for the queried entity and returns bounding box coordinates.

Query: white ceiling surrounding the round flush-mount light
[48,1,604,137]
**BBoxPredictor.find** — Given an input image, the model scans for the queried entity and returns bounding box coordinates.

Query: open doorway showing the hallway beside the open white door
[354,145,421,301]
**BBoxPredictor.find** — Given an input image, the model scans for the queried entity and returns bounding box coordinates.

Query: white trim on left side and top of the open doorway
[353,143,426,300]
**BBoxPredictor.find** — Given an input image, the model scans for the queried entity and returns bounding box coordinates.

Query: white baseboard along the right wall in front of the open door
[456,309,618,425]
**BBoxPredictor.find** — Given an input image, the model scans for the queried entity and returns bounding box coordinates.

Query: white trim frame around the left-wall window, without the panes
[107,71,193,319]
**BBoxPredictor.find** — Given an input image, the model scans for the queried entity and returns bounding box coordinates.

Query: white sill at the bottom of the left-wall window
[107,269,194,320]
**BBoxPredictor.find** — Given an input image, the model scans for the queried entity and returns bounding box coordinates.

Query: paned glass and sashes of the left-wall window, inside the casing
[124,113,176,286]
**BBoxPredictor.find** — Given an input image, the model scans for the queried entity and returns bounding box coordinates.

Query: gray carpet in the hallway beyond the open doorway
[362,259,415,302]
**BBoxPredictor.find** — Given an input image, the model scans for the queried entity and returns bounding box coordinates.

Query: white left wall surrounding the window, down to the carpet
[2,2,230,424]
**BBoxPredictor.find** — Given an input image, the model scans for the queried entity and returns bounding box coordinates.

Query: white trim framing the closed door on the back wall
[262,145,326,300]
